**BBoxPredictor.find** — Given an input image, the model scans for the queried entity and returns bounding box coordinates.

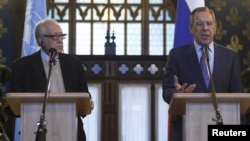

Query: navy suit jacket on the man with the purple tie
[162,43,242,141]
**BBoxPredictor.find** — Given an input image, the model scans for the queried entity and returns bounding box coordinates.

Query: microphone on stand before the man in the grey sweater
[35,61,53,141]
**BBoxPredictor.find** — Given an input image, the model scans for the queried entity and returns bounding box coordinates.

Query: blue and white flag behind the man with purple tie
[174,0,205,47]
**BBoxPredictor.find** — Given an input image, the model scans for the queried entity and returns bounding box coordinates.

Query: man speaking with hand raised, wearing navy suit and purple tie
[162,7,242,141]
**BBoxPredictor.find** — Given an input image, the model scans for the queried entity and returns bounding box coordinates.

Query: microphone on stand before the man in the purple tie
[202,45,223,125]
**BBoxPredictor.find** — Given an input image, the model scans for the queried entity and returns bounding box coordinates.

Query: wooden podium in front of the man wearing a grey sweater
[6,93,91,141]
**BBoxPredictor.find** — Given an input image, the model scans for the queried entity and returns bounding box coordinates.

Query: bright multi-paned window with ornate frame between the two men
[47,0,174,55]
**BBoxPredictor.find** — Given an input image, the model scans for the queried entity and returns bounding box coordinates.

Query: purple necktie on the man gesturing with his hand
[200,48,210,88]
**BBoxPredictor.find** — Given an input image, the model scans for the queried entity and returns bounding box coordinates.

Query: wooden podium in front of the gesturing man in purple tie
[169,93,250,141]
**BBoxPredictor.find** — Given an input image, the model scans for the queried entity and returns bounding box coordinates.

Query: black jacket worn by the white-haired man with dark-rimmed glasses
[10,51,88,141]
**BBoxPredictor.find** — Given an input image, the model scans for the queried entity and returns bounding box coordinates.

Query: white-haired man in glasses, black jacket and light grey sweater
[10,19,93,141]
